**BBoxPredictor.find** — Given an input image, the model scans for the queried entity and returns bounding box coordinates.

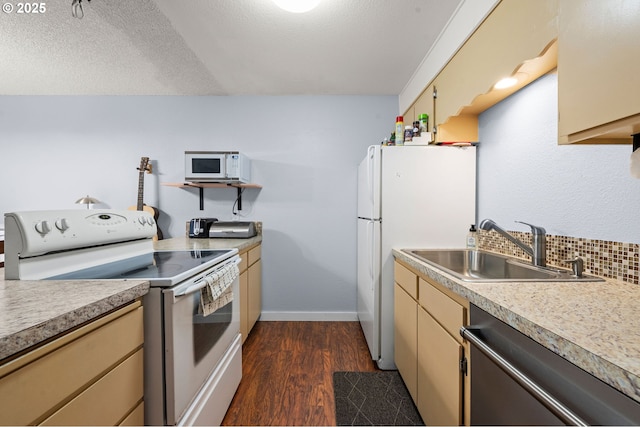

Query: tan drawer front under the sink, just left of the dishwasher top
[418,278,465,342]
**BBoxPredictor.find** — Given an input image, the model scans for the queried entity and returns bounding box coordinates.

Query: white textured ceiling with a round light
[0,0,460,95]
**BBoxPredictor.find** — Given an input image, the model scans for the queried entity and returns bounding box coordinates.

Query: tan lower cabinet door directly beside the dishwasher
[417,308,463,425]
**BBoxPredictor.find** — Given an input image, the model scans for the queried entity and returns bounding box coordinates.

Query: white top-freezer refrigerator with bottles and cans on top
[357,145,476,369]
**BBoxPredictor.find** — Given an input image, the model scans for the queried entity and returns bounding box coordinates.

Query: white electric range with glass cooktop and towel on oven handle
[5,210,242,425]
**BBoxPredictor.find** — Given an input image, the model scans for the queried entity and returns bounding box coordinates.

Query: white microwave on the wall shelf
[184,151,251,183]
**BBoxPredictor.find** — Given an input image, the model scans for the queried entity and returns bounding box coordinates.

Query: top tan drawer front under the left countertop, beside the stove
[0,307,144,425]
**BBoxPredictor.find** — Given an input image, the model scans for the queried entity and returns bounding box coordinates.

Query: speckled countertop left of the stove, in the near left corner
[0,276,149,360]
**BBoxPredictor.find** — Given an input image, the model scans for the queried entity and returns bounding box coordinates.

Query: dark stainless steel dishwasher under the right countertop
[460,305,640,425]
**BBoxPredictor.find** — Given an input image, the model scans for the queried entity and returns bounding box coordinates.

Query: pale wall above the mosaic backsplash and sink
[477,74,640,243]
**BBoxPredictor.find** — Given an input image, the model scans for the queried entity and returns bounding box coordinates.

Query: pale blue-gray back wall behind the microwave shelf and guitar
[0,96,398,319]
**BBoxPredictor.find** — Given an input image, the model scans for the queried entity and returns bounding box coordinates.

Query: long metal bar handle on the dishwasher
[460,326,589,426]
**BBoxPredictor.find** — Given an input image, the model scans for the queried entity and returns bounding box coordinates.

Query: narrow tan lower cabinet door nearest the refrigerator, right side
[393,283,418,402]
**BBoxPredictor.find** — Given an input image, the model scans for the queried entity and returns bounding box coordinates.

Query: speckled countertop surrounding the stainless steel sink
[393,249,640,401]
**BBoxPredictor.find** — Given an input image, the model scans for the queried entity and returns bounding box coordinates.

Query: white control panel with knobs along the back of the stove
[4,210,157,258]
